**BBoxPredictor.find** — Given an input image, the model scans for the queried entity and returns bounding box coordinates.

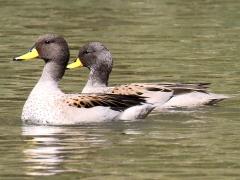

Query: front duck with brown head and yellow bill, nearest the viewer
[13,34,154,125]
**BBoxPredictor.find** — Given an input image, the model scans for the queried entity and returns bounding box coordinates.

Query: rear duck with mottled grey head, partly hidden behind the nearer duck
[67,42,228,111]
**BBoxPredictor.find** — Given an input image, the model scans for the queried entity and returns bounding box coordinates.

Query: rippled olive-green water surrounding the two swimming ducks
[0,0,240,180]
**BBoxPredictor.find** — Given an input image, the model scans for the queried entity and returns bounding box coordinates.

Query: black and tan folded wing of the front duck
[64,94,146,111]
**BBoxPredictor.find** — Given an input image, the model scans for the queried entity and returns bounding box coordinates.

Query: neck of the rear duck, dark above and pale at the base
[82,67,111,93]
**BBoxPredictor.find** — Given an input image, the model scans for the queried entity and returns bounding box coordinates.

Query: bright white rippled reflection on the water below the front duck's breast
[22,126,64,175]
